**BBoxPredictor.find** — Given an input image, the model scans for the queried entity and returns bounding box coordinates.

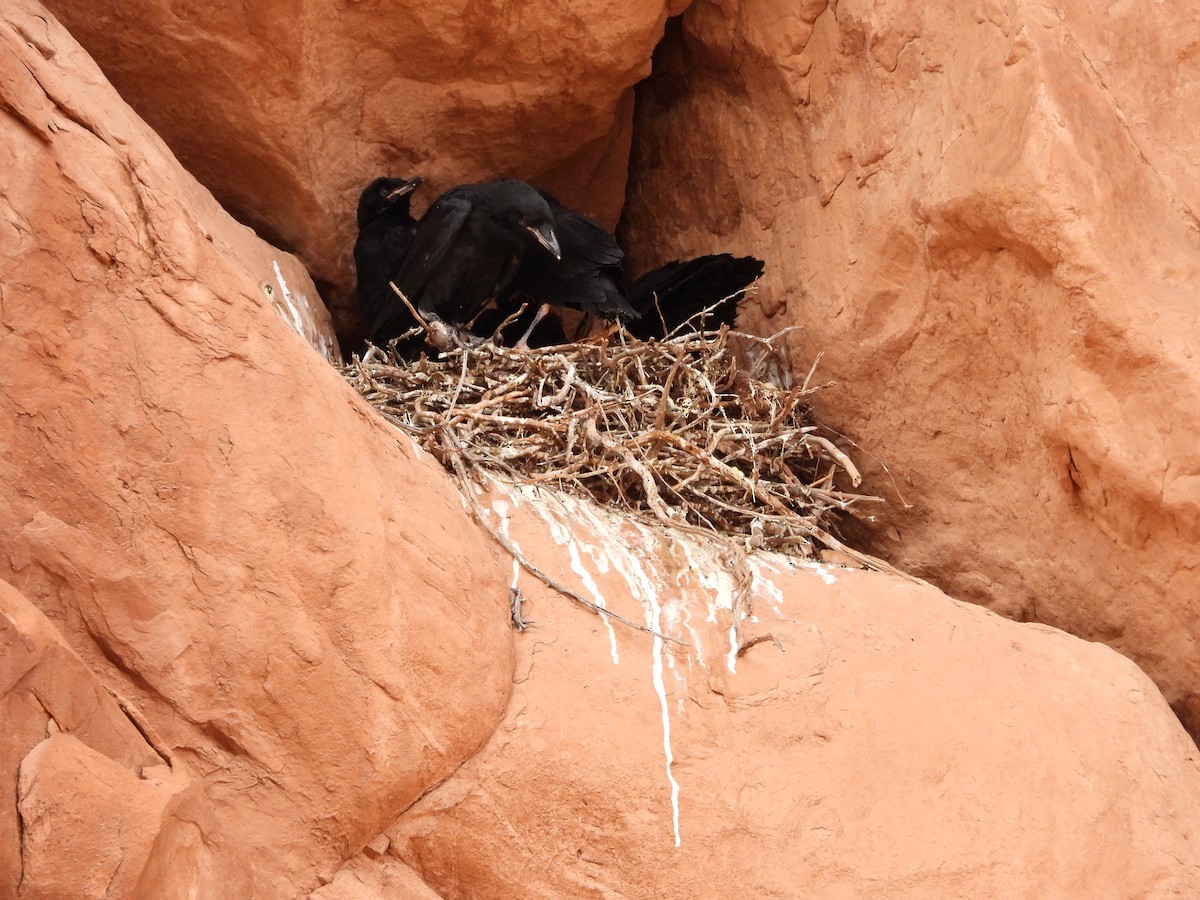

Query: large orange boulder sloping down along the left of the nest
[0,0,512,896]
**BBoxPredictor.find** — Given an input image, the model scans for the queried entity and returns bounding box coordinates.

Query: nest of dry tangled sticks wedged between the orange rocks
[343,307,895,646]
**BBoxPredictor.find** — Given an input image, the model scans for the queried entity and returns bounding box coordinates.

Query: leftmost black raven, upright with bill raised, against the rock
[354,178,421,355]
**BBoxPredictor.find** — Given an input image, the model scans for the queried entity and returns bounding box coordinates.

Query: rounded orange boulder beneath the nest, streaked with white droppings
[369,493,1200,898]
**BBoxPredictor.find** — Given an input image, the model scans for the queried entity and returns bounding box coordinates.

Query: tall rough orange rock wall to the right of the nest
[624,0,1200,734]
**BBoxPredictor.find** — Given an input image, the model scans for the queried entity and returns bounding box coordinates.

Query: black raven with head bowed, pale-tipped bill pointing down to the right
[372,179,562,345]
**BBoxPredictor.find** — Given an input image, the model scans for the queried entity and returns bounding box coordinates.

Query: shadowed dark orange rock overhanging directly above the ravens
[48,0,680,336]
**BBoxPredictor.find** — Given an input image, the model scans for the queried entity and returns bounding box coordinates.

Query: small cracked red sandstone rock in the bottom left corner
[0,582,184,898]
